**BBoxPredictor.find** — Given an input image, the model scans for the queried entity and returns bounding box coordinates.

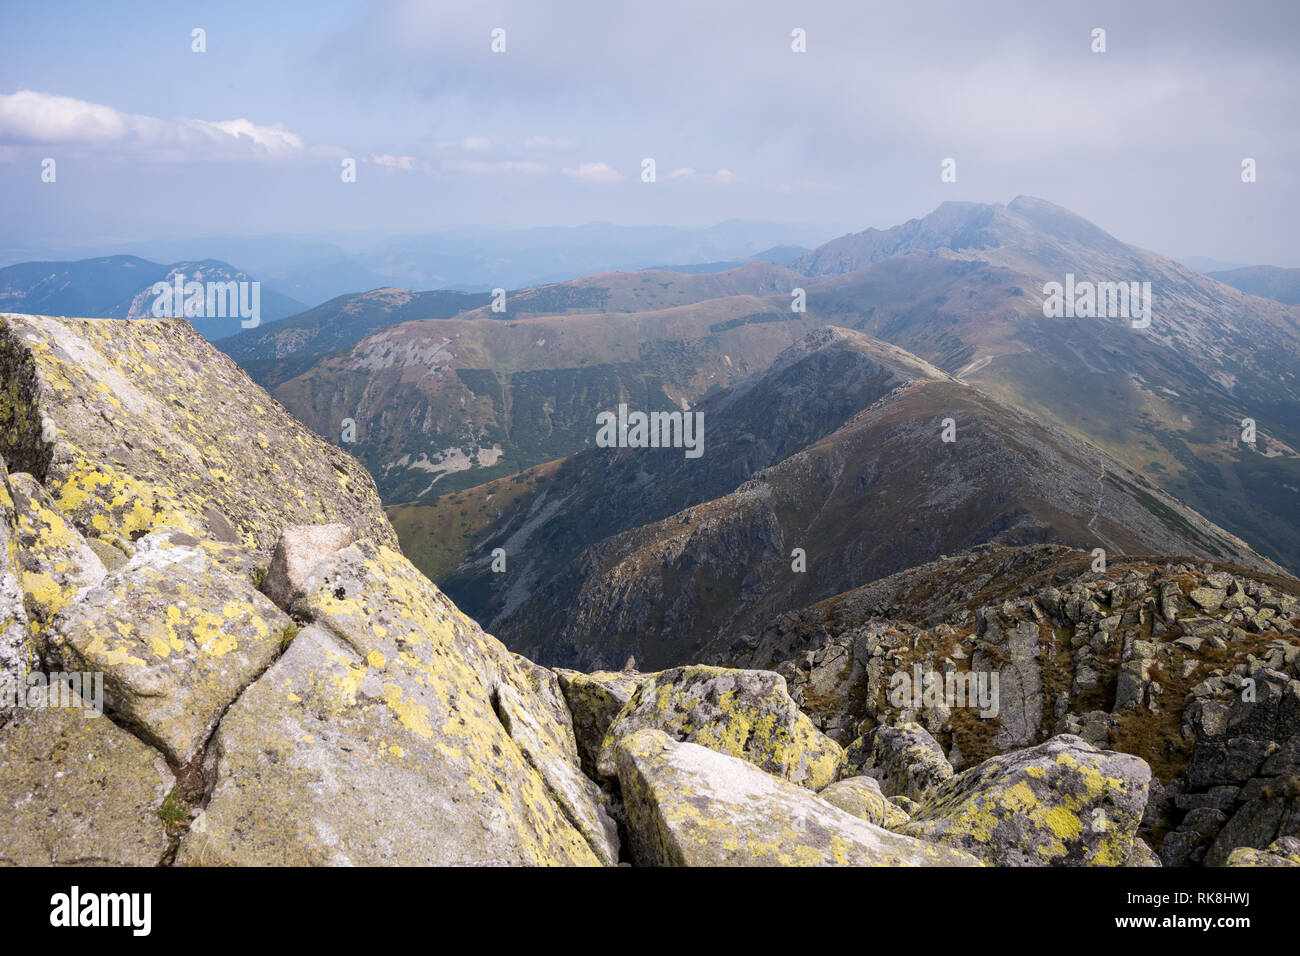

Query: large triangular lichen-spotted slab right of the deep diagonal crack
[179,542,608,865]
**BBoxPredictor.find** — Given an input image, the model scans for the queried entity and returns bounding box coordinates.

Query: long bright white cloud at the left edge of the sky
[0,90,317,161]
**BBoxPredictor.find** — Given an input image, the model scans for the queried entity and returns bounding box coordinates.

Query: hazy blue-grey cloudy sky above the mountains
[0,0,1300,267]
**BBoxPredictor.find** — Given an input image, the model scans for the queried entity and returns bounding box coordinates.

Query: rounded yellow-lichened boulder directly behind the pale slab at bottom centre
[597,666,844,790]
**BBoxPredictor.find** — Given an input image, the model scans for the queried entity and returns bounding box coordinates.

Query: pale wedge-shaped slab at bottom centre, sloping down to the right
[615,730,979,866]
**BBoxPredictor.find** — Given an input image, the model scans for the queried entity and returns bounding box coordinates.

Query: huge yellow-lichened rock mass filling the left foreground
[0,316,620,865]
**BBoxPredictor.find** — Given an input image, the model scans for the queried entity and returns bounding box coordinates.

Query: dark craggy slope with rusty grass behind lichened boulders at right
[719,545,1300,866]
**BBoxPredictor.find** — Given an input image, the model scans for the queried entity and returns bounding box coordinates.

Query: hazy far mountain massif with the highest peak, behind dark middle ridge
[208,198,1300,582]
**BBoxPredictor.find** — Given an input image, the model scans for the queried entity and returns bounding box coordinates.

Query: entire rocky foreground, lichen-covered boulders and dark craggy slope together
[0,315,1300,866]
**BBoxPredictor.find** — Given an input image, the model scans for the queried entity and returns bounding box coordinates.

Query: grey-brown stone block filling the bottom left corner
[0,691,176,866]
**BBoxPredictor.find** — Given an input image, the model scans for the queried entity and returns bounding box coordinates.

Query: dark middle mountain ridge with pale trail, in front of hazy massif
[423,326,1281,669]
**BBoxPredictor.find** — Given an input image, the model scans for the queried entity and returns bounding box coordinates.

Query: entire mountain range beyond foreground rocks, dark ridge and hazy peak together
[15,196,1300,663]
